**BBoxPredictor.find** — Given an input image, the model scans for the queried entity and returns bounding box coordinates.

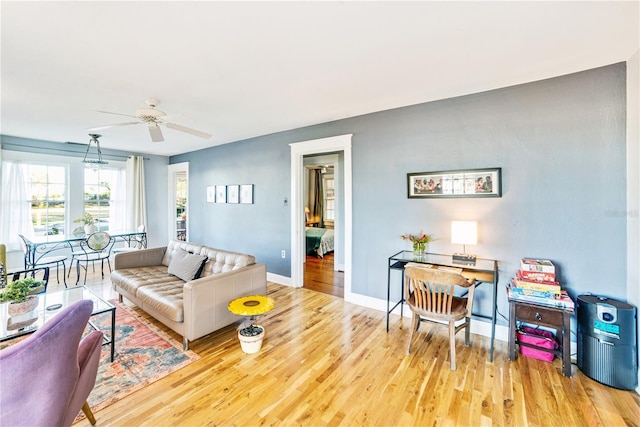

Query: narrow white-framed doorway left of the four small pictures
[168,162,189,241]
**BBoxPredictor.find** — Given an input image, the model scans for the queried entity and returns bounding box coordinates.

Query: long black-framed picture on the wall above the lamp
[407,168,502,199]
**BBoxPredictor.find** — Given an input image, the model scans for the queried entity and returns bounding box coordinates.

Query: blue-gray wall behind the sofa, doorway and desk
[170,63,626,324]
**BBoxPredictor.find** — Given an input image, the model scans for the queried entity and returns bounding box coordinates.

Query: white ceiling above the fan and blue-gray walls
[0,1,640,155]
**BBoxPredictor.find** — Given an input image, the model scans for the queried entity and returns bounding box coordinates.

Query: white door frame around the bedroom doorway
[290,134,352,301]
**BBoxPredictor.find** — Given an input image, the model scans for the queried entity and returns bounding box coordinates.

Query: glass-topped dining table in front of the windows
[24,231,147,268]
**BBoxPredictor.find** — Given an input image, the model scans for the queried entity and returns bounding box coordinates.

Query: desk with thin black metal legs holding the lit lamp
[387,251,498,362]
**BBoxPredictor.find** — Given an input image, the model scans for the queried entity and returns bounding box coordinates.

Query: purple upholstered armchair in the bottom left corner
[0,300,102,427]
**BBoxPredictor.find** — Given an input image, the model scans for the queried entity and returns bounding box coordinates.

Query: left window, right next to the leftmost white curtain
[26,164,66,236]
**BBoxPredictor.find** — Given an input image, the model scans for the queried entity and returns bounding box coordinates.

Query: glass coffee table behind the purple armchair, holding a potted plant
[0,286,116,362]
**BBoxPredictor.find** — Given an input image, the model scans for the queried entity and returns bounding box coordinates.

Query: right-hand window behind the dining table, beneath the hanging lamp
[84,168,119,231]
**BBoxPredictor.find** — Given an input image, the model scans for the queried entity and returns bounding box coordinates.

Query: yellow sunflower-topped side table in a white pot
[227,295,276,354]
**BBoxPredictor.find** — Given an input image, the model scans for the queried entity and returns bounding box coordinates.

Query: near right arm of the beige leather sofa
[183,264,267,341]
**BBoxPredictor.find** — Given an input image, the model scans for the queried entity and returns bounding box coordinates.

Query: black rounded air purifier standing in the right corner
[577,295,638,390]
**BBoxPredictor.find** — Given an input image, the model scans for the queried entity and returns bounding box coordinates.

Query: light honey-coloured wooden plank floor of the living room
[50,275,640,427]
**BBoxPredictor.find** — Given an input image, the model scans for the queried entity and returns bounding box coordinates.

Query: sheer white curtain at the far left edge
[0,161,34,251]
